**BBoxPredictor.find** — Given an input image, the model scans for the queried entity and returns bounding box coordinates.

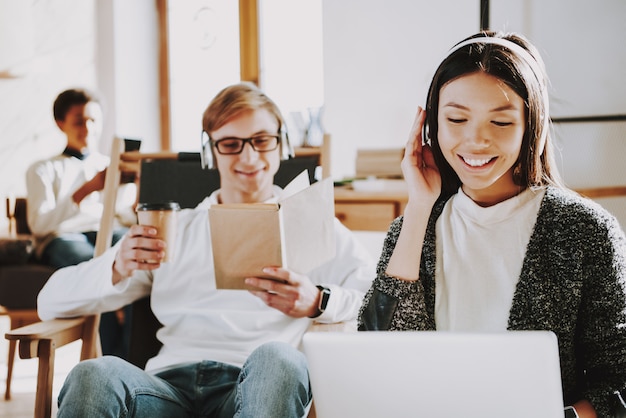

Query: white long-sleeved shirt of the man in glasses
[37,189,375,370]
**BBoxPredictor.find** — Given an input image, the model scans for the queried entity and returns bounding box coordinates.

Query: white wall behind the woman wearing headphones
[323,0,626,229]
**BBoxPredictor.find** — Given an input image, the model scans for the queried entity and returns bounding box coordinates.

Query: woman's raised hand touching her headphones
[401,107,441,212]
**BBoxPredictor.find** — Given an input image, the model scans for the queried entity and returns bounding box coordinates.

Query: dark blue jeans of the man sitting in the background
[41,228,132,358]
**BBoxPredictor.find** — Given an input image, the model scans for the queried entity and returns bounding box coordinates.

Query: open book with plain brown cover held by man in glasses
[209,172,335,289]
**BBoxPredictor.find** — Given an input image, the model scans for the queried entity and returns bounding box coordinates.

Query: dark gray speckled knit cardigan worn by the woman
[358,187,626,417]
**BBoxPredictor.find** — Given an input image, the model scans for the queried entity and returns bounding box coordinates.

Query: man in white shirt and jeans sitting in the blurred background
[26,89,136,357]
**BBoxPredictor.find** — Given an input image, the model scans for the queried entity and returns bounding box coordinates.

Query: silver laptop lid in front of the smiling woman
[303,331,563,418]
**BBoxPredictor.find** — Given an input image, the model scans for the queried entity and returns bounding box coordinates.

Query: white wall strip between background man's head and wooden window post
[96,0,161,153]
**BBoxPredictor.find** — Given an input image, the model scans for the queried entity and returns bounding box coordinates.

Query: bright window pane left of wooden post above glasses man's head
[168,0,239,151]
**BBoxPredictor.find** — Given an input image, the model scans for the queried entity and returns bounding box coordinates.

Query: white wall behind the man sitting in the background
[0,0,160,234]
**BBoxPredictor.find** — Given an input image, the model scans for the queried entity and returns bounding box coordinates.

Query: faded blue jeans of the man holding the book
[57,342,311,418]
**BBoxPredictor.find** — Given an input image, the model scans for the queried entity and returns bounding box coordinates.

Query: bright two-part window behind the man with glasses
[168,0,324,151]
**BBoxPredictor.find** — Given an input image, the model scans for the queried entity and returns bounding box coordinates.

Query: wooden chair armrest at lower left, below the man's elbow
[4,316,99,360]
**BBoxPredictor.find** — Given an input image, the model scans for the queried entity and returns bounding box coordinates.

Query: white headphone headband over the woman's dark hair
[446,36,550,155]
